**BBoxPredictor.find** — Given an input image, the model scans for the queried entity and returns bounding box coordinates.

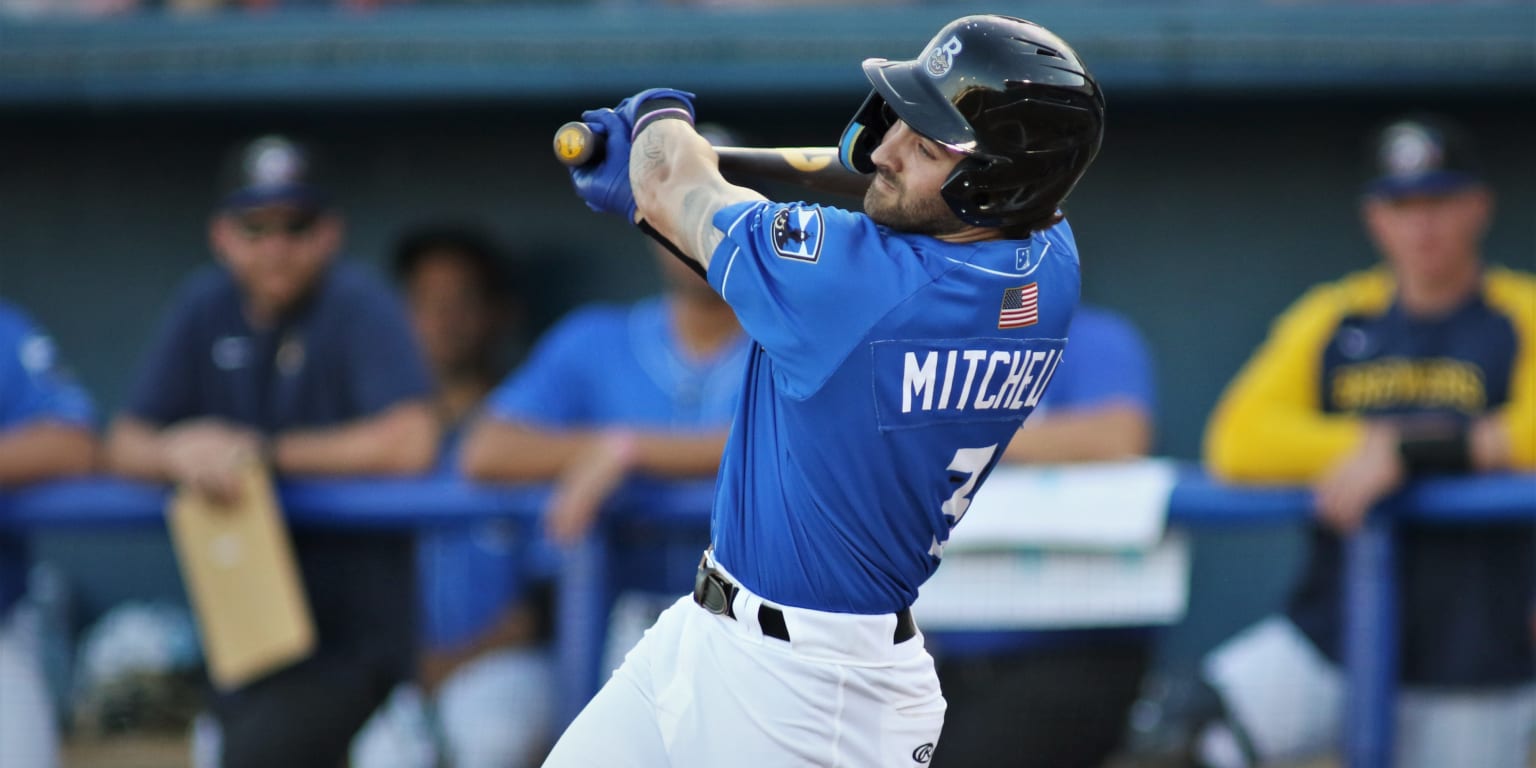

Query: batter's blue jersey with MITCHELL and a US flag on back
[708,201,1078,613]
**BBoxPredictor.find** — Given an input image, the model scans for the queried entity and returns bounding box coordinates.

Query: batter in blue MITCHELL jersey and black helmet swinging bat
[545,15,1103,766]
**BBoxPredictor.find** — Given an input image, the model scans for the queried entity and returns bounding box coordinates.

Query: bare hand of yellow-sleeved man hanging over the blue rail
[1312,422,1407,535]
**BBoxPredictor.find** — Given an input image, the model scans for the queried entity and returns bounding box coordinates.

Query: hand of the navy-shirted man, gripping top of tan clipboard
[161,419,261,504]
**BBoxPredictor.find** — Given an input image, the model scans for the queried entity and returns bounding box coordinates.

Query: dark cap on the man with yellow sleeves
[1366,115,1482,198]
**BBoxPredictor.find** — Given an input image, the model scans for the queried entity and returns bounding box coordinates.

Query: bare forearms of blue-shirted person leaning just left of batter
[459,418,727,482]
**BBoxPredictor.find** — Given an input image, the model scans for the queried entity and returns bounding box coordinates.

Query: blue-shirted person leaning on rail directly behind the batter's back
[934,304,1155,768]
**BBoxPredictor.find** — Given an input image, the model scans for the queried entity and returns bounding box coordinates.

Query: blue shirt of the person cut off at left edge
[0,301,95,611]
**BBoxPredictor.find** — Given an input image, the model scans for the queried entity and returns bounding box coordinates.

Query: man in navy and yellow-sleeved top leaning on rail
[1200,117,1536,768]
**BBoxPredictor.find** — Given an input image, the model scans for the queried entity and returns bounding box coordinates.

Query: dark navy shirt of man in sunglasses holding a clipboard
[126,263,430,660]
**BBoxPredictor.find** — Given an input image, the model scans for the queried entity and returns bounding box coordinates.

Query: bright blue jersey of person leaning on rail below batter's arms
[488,298,746,432]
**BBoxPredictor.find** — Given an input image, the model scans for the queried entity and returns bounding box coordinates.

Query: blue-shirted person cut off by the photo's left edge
[0,301,97,768]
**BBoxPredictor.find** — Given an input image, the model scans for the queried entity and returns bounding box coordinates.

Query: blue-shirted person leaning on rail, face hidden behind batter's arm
[462,239,748,672]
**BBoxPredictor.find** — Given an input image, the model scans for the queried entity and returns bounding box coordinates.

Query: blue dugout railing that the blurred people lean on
[0,468,1536,768]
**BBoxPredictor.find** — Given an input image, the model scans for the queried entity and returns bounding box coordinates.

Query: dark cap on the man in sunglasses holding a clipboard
[220,135,329,210]
